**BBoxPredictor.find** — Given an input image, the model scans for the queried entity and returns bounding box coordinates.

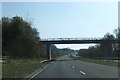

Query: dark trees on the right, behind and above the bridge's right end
[78,29,119,58]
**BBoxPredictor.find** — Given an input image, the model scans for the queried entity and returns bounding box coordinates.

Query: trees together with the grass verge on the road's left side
[0,16,63,79]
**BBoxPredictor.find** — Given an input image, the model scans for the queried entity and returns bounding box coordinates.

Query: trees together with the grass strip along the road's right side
[70,28,120,67]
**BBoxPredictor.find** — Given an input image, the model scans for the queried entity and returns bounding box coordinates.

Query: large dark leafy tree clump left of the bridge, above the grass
[2,16,44,58]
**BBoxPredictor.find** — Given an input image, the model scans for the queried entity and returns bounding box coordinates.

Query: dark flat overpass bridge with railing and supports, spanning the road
[40,38,117,60]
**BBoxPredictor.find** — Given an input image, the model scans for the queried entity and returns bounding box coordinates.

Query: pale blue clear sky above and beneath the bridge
[2,1,118,50]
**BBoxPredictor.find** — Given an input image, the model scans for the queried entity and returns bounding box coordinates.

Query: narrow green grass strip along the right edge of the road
[71,57,118,67]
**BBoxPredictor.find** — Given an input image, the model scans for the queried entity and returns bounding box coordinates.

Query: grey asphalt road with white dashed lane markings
[31,55,118,78]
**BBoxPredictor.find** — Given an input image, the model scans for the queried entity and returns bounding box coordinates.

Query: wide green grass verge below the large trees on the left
[2,59,47,78]
